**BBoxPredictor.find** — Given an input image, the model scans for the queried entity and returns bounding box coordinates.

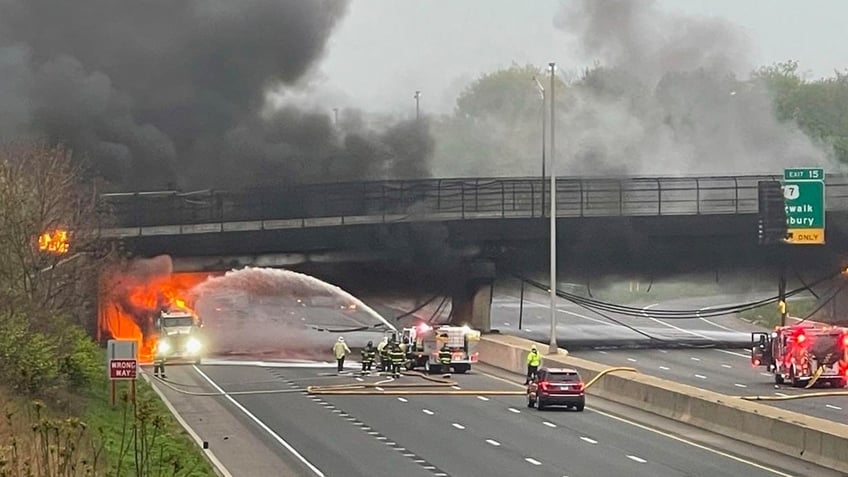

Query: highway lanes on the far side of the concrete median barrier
[492,286,848,423]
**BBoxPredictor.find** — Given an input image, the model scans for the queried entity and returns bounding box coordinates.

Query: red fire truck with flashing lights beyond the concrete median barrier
[751,323,848,388]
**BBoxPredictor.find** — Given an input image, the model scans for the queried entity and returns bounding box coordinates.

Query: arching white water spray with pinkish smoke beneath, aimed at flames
[191,267,395,357]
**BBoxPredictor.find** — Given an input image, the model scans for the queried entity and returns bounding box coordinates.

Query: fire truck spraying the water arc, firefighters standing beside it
[402,323,480,374]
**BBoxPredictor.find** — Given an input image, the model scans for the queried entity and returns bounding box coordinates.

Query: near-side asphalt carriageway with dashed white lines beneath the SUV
[154,363,836,477]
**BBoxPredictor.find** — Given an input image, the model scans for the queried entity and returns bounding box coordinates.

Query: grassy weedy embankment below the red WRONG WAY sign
[0,352,216,477]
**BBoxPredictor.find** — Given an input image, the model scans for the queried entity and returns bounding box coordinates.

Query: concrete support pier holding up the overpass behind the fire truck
[450,260,495,333]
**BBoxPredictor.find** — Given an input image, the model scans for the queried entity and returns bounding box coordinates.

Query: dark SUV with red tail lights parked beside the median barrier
[527,368,586,411]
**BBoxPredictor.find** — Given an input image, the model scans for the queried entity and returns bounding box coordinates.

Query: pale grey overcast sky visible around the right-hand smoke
[310,0,848,114]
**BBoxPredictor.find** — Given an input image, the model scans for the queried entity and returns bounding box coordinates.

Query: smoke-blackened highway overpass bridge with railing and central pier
[101,175,848,330]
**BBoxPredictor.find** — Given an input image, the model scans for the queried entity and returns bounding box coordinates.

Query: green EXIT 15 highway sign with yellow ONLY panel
[783,168,825,245]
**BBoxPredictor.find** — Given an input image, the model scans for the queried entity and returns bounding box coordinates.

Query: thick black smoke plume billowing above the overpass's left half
[0,0,432,189]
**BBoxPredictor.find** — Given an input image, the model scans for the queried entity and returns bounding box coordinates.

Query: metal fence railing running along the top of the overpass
[96,175,848,236]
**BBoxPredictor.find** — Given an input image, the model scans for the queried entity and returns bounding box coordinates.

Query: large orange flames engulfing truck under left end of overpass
[98,273,215,362]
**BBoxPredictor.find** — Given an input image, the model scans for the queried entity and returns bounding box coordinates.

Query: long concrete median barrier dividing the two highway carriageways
[478,335,848,473]
